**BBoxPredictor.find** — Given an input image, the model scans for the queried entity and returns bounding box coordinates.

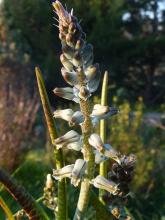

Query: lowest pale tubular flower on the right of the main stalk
[92,175,119,195]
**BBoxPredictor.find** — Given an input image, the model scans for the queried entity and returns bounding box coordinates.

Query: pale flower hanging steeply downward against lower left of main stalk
[71,159,87,186]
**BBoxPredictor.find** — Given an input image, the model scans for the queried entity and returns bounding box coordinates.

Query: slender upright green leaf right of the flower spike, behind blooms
[99,71,108,204]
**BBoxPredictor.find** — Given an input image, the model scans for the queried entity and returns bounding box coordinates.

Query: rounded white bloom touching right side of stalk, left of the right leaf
[88,134,104,152]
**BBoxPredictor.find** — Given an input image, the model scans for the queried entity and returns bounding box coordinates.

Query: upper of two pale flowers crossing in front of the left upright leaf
[54,130,81,149]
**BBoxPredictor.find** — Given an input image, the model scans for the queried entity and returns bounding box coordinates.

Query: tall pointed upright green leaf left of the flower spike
[35,67,67,220]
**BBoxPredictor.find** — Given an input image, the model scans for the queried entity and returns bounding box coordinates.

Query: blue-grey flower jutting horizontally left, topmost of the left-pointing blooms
[53,87,79,103]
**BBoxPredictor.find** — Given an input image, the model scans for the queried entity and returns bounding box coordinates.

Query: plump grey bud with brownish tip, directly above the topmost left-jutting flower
[61,68,79,86]
